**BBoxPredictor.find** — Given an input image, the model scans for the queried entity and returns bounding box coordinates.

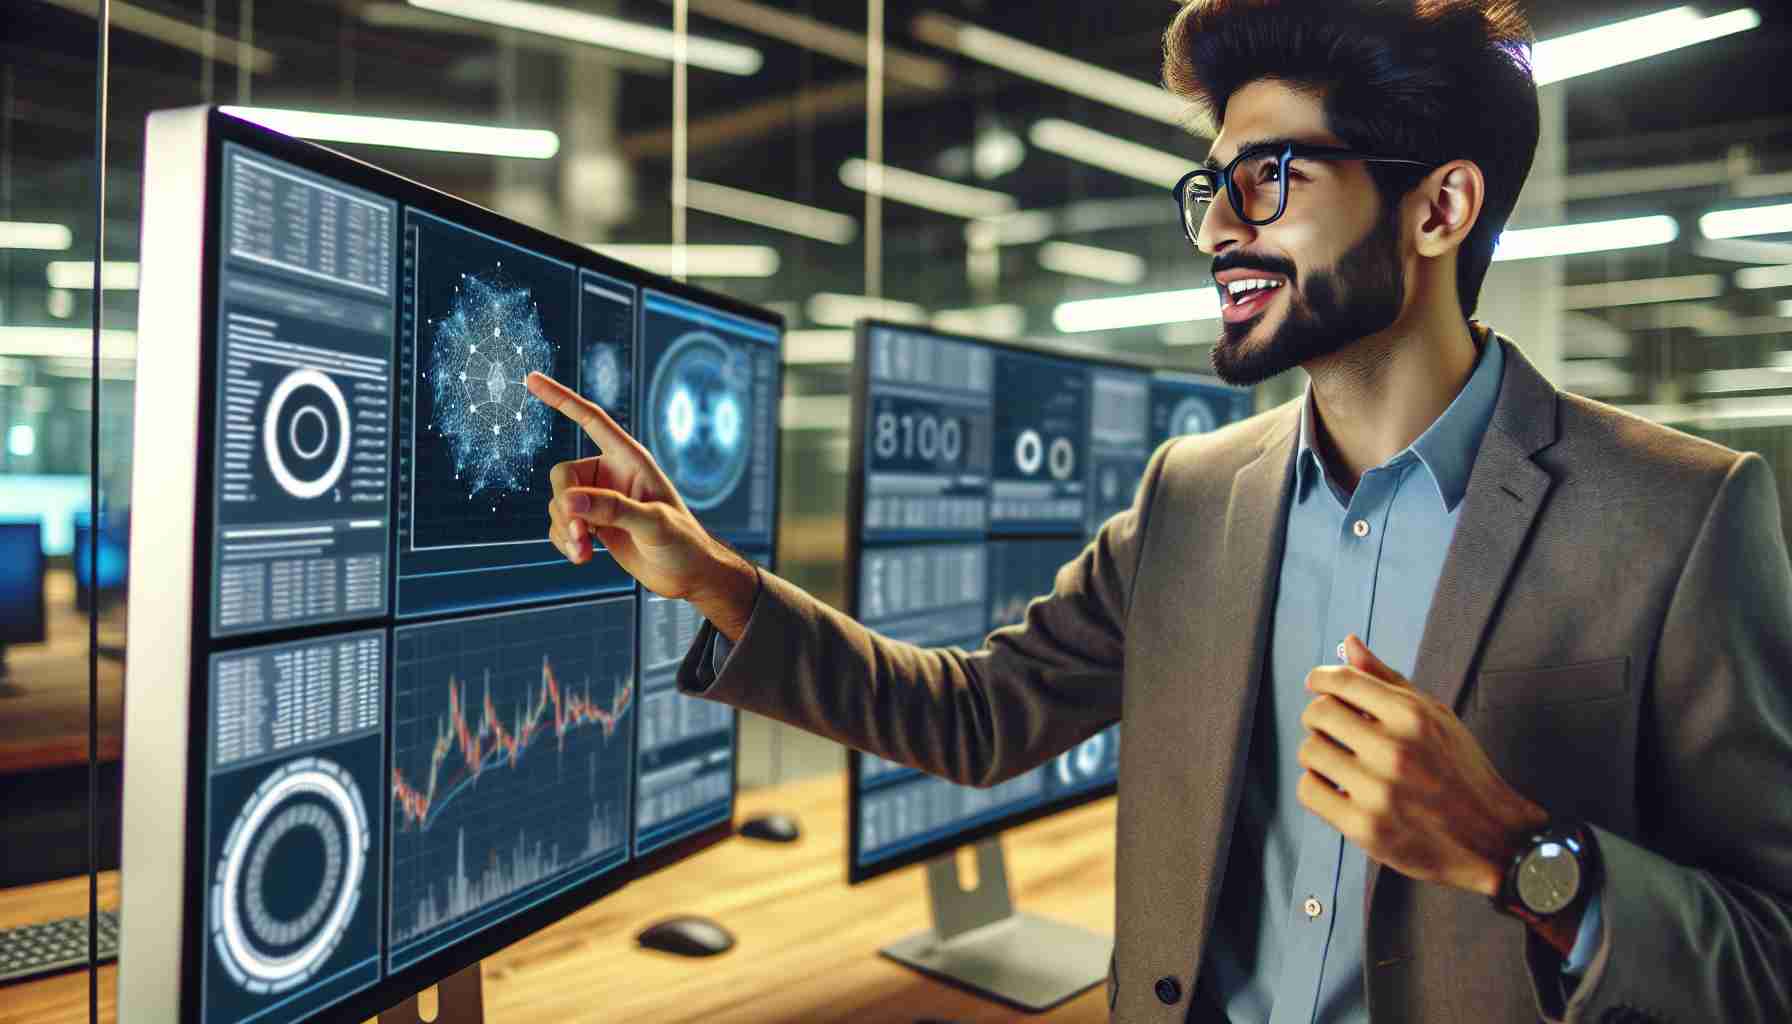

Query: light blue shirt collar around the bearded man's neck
[1294,328,1505,511]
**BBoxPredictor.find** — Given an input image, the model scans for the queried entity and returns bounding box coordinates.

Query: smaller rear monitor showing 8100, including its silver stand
[848,321,1251,1010]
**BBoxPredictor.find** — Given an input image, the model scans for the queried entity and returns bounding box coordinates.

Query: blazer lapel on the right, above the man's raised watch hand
[1364,335,1557,914]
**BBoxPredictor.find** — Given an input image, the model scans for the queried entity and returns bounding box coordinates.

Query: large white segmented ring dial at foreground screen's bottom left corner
[210,757,369,994]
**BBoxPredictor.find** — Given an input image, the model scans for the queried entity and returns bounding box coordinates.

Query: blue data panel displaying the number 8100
[862,326,995,542]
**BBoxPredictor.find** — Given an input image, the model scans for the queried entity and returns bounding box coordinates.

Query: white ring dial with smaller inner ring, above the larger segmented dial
[262,369,349,500]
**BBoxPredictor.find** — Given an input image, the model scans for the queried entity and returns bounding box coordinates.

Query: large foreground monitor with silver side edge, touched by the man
[118,108,783,1024]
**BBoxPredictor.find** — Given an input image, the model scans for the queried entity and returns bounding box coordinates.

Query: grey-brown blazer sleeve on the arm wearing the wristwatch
[1527,454,1792,1022]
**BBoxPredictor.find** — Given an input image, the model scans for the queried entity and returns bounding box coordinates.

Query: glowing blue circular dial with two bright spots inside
[645,332,753,509]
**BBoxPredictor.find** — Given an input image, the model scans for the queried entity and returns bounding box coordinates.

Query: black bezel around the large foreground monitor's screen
[141,106,785,1024]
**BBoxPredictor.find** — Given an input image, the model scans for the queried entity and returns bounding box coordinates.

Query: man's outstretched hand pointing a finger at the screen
[527,373,758,640]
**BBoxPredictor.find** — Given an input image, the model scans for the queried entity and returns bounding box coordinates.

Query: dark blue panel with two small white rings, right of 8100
[989,351,1090,534]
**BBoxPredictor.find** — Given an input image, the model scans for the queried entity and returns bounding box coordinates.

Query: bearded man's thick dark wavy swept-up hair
[1163,0,1538,317]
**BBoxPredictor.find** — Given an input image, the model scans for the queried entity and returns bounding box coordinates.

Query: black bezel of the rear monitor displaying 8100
[846,319,1154,886]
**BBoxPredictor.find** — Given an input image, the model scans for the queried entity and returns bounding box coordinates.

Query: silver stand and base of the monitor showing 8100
[878,839,1113,1024]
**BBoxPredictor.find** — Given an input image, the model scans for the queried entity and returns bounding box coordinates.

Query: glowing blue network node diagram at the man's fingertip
[428,262,554,499]
